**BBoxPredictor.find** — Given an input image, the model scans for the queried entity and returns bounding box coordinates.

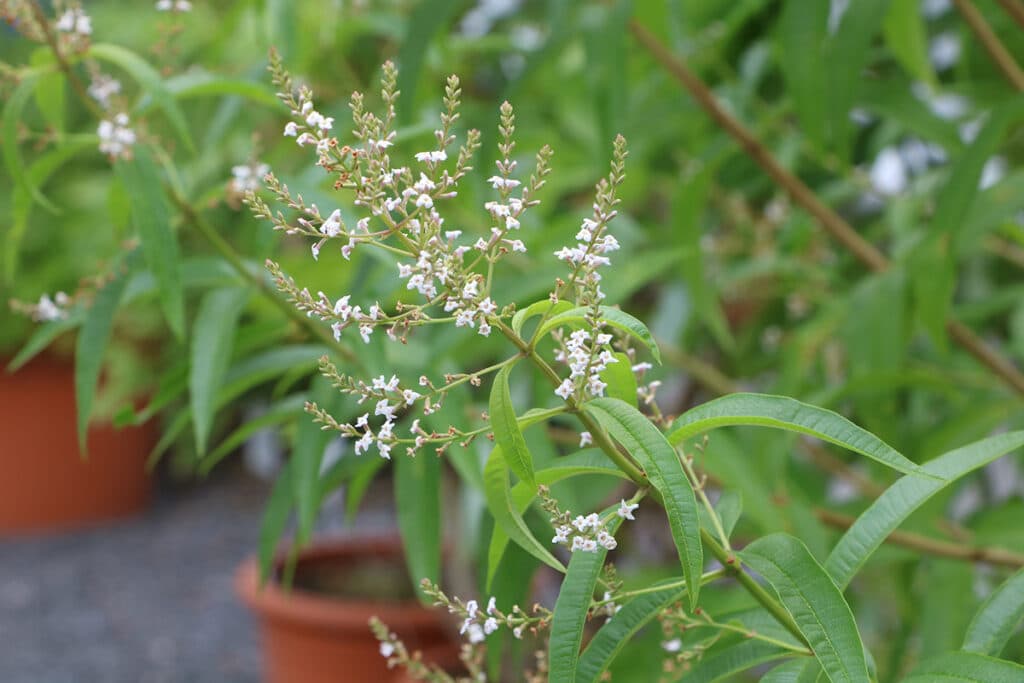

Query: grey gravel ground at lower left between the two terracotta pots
[0,475,266,683]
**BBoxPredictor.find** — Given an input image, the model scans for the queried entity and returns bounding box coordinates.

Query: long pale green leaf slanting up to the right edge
[825,431,1024,589]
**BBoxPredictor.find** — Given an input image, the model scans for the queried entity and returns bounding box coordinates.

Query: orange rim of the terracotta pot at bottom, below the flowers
[234,537,445,635]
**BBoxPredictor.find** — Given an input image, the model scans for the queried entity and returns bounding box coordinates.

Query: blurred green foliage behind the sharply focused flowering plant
[6,0,1024,680]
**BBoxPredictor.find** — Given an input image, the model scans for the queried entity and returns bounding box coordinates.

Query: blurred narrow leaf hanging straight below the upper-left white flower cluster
[117,146,185,339]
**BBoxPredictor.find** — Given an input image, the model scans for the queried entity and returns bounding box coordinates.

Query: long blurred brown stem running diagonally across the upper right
[630,18,1024,395]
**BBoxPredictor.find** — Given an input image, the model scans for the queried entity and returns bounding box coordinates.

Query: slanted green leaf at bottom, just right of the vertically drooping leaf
[575,580,686,683]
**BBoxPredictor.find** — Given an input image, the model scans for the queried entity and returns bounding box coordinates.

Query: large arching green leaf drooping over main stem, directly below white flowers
[584,398,703,607]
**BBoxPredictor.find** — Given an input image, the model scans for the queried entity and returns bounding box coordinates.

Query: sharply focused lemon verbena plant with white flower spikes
[246,57,1024,683]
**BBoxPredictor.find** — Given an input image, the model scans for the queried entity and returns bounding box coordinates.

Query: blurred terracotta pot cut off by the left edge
[0,357,156,536]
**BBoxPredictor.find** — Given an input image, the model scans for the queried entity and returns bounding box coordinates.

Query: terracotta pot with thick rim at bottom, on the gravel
[236,538,459,683]
